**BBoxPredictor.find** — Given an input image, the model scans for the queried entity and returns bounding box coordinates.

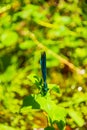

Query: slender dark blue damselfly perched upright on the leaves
[40,51,48,95]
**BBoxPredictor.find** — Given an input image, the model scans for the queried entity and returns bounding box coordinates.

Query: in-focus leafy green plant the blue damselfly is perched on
[21,74,67,130]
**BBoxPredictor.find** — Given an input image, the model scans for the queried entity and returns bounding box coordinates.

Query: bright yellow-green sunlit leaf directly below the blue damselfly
[36,93,66,122]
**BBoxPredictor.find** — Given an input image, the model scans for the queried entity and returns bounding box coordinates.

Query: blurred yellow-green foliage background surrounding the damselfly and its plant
[0,0,87,130]
